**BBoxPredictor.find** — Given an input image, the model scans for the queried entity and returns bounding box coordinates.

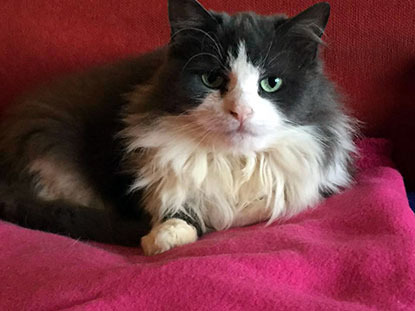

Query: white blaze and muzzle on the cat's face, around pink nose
[194,43,285,155]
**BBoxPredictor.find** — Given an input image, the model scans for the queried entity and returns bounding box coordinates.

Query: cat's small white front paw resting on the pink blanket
[141,218,197,256]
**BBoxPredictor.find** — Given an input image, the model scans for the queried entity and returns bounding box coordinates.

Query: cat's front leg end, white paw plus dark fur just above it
[141,212,203,256]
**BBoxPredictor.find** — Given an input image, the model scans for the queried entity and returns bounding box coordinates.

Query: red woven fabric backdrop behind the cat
[0,0,415,182]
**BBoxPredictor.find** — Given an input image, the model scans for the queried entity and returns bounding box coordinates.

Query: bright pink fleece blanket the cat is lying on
[0,139,415,311]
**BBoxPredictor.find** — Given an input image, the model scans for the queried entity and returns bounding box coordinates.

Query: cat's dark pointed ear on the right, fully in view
[280,2,330,63]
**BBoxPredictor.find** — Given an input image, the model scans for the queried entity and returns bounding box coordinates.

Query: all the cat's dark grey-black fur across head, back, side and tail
[0,0,354,249]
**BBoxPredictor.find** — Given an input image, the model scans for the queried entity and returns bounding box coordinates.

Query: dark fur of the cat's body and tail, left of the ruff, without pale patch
[0,49,166,244]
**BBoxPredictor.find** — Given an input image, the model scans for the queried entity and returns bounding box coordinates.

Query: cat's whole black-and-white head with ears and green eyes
[137,0,330,153]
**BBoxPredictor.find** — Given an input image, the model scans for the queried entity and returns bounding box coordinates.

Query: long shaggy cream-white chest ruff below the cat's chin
[125,118,324,230]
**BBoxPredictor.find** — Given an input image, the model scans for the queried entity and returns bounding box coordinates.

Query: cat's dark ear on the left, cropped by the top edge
[168,0,214,36]
